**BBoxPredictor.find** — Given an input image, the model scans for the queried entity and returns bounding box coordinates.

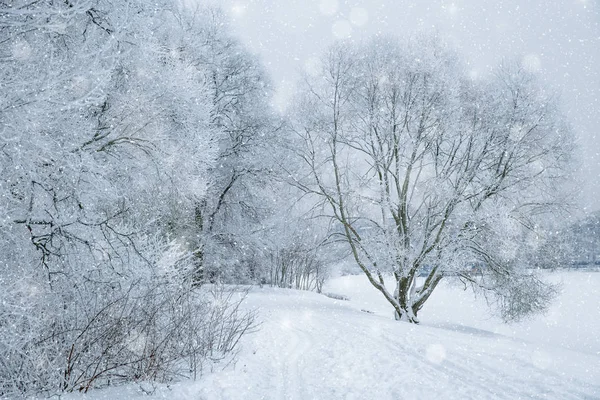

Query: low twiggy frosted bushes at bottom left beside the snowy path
[0,242,253,396]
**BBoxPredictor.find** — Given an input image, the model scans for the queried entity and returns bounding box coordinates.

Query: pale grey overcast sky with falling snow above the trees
[219,0,600,216]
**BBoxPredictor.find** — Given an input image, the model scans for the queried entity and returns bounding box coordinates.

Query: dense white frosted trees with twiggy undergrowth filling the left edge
[0,0,251,396]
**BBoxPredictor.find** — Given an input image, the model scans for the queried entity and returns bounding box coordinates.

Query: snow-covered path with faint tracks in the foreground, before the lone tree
[192,282,600,400]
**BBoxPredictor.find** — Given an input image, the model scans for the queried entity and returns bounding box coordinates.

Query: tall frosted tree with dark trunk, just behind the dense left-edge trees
[185,9,278,280]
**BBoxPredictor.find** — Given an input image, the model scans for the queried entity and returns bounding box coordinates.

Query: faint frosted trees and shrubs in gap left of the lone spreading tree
[257,145,348,292]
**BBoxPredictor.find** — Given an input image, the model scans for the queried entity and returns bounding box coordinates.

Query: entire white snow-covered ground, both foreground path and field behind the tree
[63,272,600,400]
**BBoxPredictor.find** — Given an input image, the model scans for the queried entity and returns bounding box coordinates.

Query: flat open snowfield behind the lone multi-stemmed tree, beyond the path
[323,271,600,356]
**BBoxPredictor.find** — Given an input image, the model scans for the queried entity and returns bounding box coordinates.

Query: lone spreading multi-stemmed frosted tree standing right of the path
[292,38,573,323]
